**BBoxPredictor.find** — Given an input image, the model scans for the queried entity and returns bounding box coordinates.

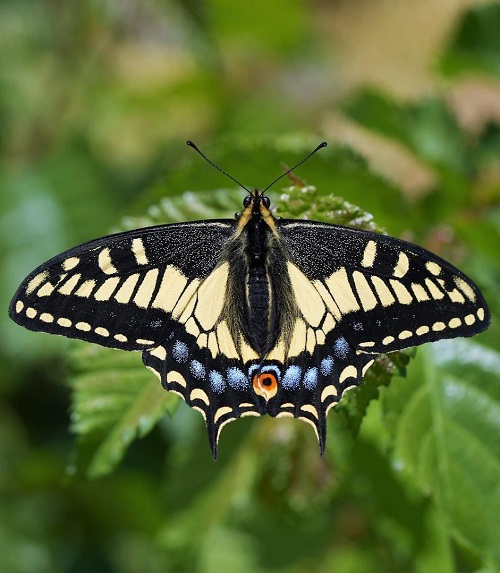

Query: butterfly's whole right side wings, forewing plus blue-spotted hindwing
[262,220,490,450]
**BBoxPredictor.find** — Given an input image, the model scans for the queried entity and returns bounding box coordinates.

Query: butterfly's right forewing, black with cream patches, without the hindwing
[278,220,490,354]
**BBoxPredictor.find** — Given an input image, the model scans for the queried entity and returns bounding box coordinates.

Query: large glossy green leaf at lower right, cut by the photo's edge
[382,340,500,567]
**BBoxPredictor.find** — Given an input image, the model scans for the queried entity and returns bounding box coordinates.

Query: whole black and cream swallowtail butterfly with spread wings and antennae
[9,142,490,459]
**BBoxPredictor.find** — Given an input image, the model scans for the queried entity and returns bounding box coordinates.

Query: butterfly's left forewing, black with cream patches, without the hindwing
[9,220,234,350]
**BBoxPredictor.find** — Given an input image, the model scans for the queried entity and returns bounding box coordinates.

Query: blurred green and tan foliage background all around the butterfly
[0,0,500,573]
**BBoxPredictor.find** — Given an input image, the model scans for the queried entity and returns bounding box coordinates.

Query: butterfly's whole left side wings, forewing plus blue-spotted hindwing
[9,220,265,457]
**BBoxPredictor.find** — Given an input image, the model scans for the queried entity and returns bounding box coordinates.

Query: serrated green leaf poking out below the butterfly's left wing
[69,343,179,477]
